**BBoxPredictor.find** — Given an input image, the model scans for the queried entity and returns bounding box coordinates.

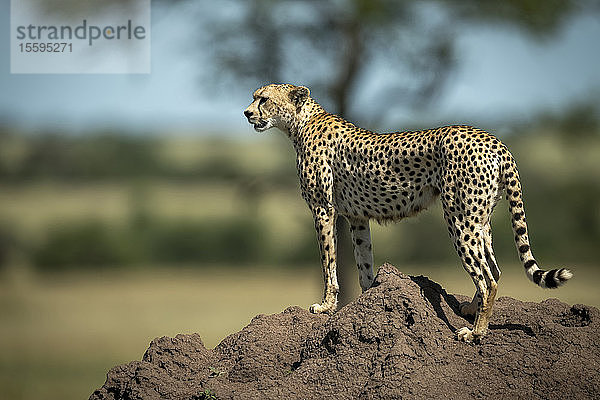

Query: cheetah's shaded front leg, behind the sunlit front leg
[346,217,373,293]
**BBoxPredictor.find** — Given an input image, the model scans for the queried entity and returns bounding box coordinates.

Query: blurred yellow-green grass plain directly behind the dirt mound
[0,262,600,400]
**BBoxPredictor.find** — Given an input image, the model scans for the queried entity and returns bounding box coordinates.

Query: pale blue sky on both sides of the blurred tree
[0,0,600,135]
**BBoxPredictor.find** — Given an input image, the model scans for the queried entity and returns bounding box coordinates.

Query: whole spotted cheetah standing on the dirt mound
[244,84,572,342]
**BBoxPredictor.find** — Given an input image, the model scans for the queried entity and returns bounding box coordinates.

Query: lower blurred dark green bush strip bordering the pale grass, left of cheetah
[33,217,272,269]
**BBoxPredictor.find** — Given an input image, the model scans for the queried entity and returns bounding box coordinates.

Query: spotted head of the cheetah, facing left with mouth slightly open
[244,84,310,132]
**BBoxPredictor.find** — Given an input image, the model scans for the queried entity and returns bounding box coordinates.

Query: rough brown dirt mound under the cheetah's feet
[90,264,600,400]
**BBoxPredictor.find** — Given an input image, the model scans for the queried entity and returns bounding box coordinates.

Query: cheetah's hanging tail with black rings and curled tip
[502,153,573,288]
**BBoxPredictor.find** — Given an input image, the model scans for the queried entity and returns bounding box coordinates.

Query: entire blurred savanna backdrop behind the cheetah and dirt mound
[0,0,600,399]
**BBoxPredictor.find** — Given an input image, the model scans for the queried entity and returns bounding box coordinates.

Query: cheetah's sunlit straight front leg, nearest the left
[309,207,339,313]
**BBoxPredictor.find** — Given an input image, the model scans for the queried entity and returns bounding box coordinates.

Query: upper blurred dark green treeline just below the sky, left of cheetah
[0,131,295,186]
